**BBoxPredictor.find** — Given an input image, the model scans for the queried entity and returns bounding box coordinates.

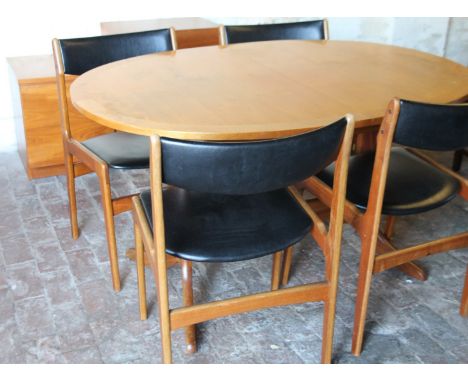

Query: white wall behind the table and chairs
[0,13,468,140]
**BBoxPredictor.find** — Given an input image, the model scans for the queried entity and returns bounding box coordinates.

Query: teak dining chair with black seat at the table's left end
[52,29,176,291]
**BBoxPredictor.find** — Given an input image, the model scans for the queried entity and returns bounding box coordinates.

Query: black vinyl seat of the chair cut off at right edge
[318,148,460,216]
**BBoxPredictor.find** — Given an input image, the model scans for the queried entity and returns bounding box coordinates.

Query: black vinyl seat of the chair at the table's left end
[81,133,149,170]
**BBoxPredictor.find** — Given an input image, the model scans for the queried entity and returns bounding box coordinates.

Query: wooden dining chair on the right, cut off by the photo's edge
[282,99,468,355]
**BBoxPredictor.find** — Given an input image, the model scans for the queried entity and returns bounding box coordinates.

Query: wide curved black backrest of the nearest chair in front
[161,118,347,195]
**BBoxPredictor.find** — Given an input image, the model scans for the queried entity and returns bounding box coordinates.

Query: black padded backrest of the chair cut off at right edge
[393,100,468,151]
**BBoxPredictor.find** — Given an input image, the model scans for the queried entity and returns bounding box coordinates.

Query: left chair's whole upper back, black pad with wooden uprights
[52,28,177,138]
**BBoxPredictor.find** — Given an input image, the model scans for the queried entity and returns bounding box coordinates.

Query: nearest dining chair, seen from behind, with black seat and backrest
[133,116,354,363]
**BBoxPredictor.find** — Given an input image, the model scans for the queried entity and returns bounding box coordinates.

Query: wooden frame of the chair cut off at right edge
[285,99,468,355]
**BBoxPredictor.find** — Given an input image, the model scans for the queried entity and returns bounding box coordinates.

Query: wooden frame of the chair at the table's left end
[52,28,177,292]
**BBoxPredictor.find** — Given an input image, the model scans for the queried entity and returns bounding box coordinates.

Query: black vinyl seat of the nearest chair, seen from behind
[140,187,312,262]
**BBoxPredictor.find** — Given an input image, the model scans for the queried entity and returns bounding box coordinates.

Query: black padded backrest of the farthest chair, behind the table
[225,20,325,44]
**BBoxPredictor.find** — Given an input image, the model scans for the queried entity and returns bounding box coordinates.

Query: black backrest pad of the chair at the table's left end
[59,29,173,75]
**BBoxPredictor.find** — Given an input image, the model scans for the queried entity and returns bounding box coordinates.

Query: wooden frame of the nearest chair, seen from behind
[132,115,354,363]
